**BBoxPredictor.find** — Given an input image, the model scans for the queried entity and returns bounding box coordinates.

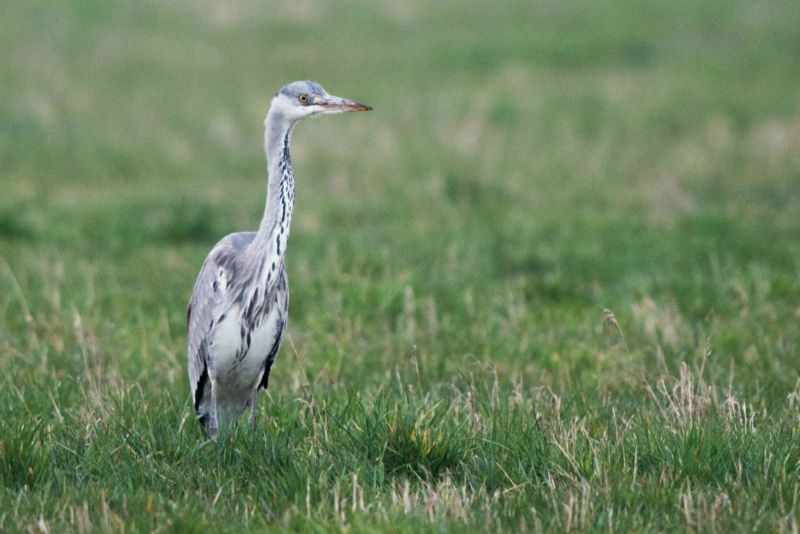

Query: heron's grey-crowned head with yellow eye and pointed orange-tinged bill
[270,80,372,122]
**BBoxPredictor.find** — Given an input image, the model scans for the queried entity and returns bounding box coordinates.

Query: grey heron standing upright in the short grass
[186,80,372,438]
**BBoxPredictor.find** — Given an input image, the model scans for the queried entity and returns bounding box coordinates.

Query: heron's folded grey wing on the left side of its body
[186,232,255,409]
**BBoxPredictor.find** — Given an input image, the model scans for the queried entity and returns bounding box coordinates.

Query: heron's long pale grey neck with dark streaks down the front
[255,111,294,265]
